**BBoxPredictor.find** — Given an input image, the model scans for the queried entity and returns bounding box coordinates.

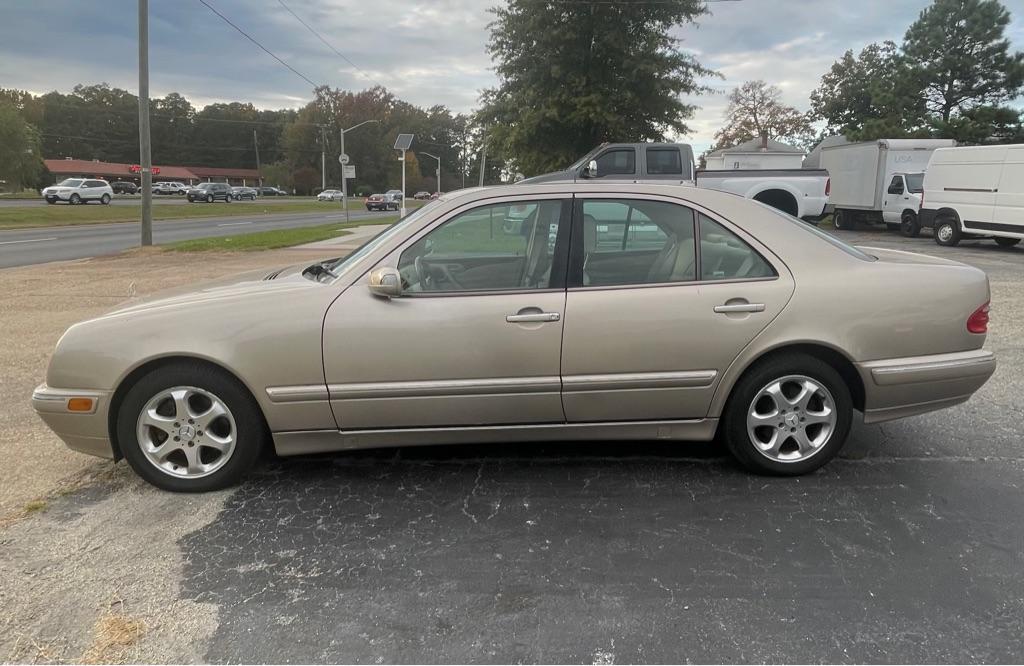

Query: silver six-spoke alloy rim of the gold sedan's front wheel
[136,386,238,478]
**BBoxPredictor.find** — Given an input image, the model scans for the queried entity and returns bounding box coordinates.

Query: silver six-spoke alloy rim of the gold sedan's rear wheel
[746,375,837,462]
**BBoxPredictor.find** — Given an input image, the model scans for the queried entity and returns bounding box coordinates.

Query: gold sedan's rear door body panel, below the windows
[562,274,793,422]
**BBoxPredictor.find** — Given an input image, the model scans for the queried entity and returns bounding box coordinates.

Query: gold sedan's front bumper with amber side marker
[32,384,115,458]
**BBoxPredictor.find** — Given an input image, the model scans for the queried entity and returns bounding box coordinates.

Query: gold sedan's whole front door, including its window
[324,198,570,430]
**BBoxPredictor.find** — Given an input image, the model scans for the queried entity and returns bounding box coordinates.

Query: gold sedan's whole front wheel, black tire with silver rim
[117,362,269,493]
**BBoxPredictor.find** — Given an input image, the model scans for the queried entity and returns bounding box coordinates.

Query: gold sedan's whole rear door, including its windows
[562,198,794,422]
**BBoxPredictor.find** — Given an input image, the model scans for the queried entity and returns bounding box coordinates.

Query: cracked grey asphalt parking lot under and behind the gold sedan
[0,226,1024,664]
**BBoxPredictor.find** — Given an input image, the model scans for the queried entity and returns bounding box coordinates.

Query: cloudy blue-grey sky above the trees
[0,0,1024,152]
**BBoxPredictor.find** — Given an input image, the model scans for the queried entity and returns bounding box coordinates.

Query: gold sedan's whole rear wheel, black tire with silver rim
[720,353,853,476]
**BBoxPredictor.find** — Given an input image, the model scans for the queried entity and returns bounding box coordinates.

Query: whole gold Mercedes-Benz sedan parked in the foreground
[32,182,995,491]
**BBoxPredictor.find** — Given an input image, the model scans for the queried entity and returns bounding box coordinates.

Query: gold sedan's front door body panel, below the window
[324,284,565,429]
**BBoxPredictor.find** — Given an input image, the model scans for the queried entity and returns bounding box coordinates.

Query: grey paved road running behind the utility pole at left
[0,209,394,268]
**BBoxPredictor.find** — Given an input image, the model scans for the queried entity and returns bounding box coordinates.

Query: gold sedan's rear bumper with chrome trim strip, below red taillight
[857,349,995,423]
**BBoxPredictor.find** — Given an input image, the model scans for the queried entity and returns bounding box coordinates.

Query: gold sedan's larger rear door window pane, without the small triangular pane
[573,199,696,287]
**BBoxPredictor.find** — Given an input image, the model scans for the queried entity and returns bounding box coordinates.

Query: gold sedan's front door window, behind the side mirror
[398,200,564,294]
